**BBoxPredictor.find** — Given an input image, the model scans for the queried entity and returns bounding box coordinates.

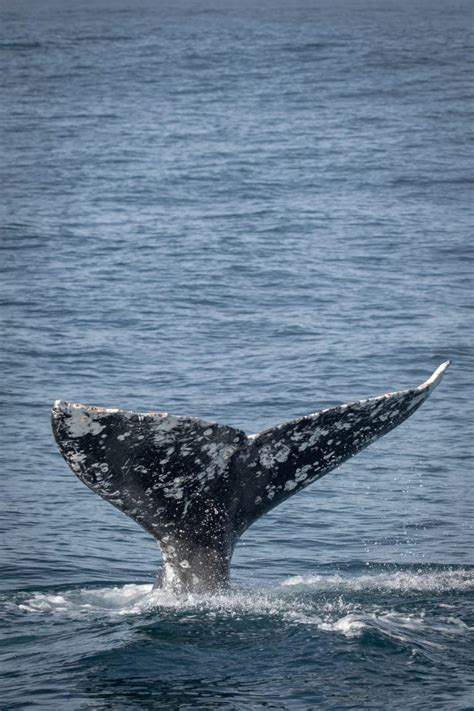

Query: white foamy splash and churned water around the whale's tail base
[6,568,474,653]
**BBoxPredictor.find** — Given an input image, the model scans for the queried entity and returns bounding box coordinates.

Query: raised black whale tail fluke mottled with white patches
[52,362,449,592]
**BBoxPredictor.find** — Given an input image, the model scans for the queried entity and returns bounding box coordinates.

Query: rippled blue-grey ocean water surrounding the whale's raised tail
[0,0,474,711]
